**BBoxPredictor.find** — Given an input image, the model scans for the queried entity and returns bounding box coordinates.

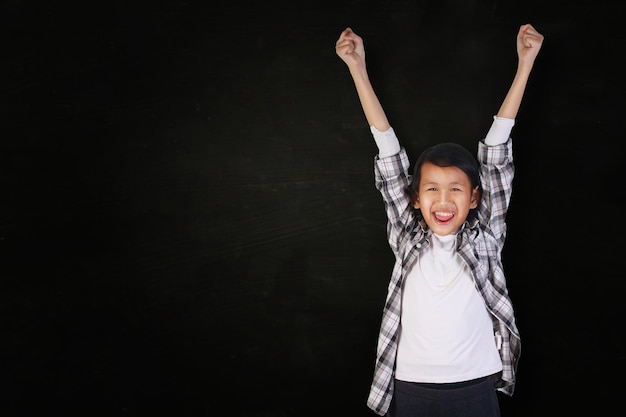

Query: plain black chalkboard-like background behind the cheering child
[0,0,626,417]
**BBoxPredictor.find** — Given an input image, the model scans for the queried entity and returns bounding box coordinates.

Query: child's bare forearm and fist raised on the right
[497,24,543,119]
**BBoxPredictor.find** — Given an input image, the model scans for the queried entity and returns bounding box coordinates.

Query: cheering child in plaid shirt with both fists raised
[335,24,543,417]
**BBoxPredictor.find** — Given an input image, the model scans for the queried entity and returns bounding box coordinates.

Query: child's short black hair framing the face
[408,143,483,214]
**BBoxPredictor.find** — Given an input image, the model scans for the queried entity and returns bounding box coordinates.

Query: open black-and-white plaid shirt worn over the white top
[367,139,521,416]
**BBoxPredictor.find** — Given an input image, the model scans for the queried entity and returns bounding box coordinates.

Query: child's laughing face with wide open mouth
[414,162,478,236]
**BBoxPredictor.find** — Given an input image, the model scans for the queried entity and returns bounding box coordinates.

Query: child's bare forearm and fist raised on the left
[335,28,390,131]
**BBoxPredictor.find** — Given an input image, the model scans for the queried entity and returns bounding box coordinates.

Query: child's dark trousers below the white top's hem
[387,377,500,417]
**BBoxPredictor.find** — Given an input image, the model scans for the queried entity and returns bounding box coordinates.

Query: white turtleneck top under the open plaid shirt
[396,233,502,383]
